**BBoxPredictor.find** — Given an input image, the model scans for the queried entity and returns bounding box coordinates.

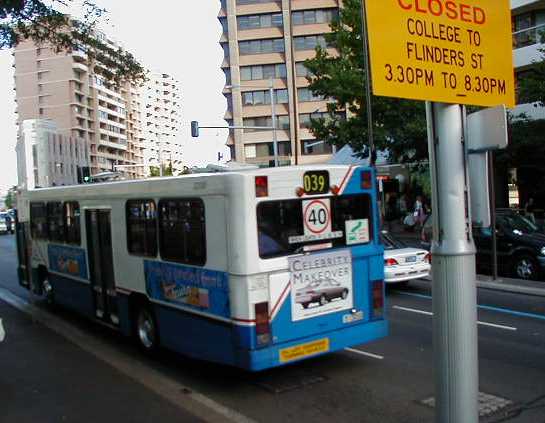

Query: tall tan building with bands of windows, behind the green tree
[218,0,340,166]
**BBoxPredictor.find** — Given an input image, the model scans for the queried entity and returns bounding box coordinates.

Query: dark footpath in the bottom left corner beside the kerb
[0,300,202,423]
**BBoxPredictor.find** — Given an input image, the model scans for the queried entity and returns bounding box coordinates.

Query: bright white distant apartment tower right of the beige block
[142,72,183,174]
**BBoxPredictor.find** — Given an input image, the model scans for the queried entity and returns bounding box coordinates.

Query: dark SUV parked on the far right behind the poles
[421,209,545,280]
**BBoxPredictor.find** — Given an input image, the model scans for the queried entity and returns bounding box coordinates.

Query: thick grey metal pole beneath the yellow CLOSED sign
[426,102,479,423]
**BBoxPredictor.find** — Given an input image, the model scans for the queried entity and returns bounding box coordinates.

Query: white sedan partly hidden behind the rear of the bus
[381,232,431,283]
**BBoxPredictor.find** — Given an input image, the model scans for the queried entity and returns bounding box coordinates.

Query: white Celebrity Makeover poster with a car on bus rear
[289,249,354,321]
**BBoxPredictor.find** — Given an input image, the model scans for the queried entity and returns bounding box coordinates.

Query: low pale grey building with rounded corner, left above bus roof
[15,119,89,189]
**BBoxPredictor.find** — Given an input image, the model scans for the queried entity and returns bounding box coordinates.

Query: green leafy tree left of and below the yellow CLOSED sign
[305,0,428,162]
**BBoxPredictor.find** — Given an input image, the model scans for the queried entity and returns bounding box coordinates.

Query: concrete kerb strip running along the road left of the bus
[0,288,257,423]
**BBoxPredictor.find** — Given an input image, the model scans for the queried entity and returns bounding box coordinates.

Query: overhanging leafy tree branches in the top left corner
[0,0,146,85]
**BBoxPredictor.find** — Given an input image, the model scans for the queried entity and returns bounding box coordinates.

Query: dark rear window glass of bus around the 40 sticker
[257,194,373,258]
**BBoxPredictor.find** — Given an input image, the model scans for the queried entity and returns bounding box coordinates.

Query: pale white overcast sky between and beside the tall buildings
[0,0,229,196]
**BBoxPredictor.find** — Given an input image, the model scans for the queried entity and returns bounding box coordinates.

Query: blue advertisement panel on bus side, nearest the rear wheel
[144,261,230,318]
